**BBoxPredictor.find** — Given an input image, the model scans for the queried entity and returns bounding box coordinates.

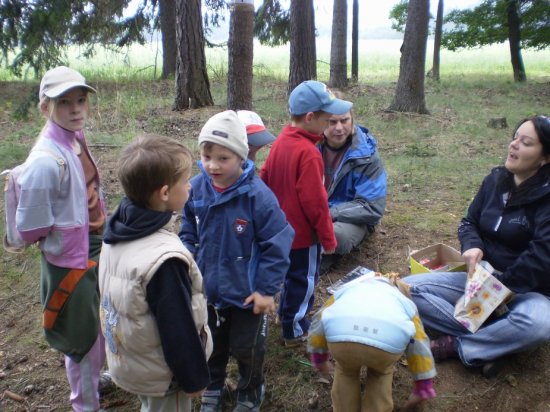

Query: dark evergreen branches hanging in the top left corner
[0,0,156,77]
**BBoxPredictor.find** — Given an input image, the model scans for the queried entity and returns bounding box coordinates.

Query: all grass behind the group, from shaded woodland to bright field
[0,40,550,251]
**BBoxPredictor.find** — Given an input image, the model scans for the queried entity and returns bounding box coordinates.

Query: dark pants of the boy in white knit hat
[207,305,267,404]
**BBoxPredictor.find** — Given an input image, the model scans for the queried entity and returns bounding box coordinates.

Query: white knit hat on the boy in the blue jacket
[199,110,248,159]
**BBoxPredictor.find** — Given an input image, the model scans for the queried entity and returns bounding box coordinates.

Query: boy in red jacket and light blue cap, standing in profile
[260,80,352,347]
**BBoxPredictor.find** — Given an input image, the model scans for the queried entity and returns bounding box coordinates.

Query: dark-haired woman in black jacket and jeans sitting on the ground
[405,116,550,376]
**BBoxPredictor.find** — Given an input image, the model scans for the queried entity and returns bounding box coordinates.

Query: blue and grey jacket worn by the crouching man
[319,126,387,226]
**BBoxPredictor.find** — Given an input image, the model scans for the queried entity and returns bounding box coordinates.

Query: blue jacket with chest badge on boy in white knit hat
[179,160,294,308]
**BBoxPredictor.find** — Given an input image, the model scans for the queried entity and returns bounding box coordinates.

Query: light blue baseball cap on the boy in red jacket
[288,80,353,116]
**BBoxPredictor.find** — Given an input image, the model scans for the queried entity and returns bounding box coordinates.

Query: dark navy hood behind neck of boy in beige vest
[103,198,173,244]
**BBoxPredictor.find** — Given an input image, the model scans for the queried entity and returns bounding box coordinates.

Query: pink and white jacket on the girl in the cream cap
[16,121,105,269]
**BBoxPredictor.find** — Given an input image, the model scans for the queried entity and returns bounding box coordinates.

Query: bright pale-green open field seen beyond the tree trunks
[0,38,550,83]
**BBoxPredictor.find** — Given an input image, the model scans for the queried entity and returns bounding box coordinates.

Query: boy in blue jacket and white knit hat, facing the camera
[180,110,294,412]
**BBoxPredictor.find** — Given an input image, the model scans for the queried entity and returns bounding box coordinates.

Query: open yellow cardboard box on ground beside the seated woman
[409,243,466,275]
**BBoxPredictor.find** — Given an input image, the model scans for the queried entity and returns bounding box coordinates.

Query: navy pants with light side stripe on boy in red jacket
[278,244,321,339]
